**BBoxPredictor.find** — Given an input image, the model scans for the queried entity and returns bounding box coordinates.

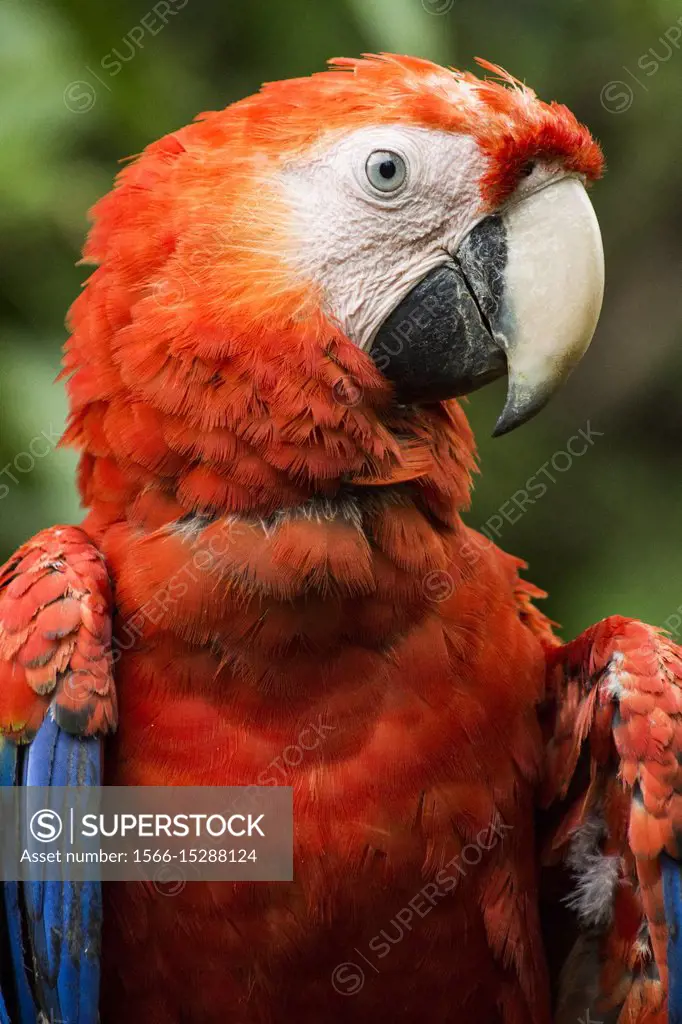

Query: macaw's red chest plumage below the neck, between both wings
[102,487,544,1022]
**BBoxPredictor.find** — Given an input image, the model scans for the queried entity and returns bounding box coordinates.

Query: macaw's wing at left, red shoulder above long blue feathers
[0,526,116,1024]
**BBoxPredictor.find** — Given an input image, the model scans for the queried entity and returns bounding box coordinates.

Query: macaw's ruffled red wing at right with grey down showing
[544,616,682,1024]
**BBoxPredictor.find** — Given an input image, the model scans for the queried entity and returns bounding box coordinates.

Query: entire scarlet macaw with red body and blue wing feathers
[0,54,682,1024]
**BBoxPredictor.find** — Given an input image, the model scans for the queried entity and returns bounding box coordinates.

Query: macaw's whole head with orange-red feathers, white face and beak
[66,54,603,520]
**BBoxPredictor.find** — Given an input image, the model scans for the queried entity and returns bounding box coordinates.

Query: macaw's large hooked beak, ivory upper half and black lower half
[371,177,604,435]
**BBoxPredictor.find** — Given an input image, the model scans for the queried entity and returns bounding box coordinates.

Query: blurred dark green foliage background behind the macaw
[0,0,682,634]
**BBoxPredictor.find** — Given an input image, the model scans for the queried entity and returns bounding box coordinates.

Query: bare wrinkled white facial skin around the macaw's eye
[282,125,486,349]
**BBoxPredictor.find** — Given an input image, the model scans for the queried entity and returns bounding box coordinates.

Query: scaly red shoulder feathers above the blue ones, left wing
[0,526,117,742]
